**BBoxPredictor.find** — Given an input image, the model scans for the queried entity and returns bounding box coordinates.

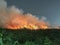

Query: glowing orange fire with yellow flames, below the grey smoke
[4,14,48,29]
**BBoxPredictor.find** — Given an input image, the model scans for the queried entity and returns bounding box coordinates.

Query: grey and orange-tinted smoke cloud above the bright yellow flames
[0,0,50,28]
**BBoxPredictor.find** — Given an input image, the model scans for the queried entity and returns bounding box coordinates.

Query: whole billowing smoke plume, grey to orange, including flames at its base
[0,0,49,28]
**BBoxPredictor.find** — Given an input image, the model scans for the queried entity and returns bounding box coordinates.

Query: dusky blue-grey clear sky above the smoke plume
[5,0,60,26]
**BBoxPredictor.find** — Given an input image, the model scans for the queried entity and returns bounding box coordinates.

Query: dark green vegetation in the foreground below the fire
[0,28,60,45]
